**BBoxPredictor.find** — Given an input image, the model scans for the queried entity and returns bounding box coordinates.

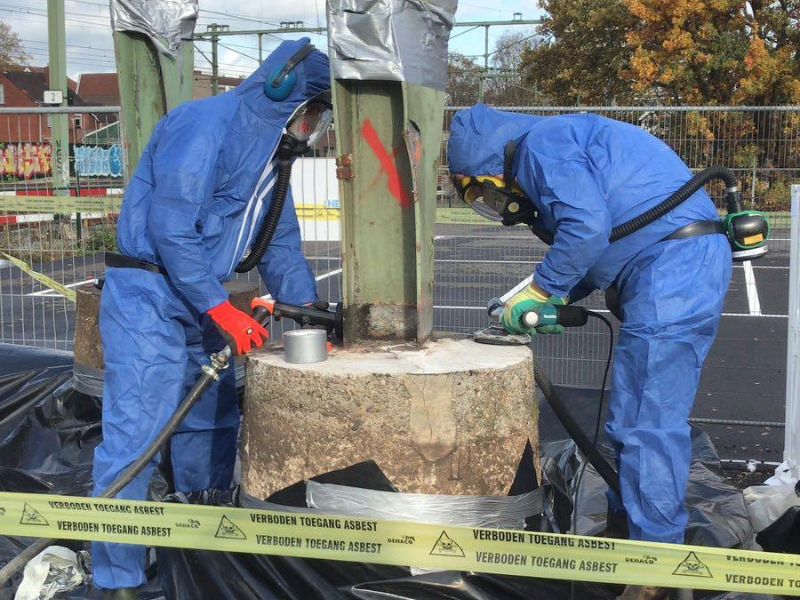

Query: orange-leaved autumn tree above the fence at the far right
[622,0,800,104]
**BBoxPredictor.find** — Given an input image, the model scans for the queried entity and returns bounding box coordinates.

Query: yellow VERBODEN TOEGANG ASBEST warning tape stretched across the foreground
[0,493,800,596]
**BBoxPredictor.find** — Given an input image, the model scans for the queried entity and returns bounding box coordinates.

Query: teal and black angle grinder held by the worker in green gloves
[473,298,589,346]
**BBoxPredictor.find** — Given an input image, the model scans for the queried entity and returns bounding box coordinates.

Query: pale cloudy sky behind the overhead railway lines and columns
[0,0,542,79]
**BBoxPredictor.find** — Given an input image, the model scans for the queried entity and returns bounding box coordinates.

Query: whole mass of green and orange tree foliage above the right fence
[523,0,800,104]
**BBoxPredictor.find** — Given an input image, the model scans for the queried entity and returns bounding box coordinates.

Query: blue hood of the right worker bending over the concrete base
[447,104,544,176]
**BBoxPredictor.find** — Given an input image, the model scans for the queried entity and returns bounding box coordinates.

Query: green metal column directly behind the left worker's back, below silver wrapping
[114,31,194,177]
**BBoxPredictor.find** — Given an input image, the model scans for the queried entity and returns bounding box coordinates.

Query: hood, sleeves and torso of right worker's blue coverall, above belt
[447,104,718,298]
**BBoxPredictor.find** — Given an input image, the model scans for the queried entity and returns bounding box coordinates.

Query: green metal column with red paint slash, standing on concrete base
[334,80,445,344]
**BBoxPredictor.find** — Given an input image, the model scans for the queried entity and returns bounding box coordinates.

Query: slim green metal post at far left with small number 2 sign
[47,0,69,192]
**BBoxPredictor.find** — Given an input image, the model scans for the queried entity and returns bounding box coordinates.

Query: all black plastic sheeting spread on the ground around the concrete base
[0,347,788,600]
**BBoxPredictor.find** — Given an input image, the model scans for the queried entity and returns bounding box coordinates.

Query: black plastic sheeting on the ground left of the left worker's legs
[0,344,164,600]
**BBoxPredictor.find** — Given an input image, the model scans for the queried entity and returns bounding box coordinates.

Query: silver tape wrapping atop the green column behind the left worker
[111,0,200,56]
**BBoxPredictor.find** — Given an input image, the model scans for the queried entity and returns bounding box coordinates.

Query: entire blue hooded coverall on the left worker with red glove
[92,38,330,588]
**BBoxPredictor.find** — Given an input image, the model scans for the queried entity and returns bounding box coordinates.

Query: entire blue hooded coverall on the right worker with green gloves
[448,104,731,543]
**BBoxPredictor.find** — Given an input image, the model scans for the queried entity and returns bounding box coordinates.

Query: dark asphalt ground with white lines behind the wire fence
[0,224,789,463]
